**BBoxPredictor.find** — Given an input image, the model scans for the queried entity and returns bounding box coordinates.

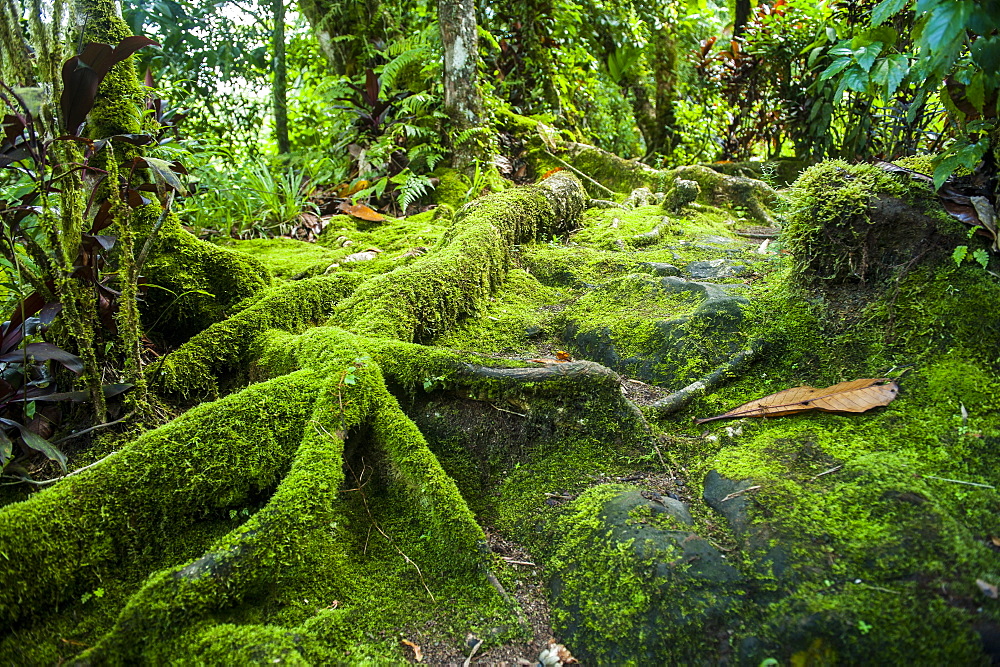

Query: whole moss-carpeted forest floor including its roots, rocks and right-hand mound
[0,158,1000,665]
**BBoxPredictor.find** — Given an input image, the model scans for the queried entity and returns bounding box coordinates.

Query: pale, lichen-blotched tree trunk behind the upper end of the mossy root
[438,0,486,171]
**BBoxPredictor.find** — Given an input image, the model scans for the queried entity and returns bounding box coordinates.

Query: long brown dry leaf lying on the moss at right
[694,378,899,424]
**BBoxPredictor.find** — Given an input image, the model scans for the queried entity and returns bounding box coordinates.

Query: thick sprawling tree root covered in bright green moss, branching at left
[0,174,641,664]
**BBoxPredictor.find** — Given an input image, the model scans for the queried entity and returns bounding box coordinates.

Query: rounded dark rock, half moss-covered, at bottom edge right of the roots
[550,485,743,665]
